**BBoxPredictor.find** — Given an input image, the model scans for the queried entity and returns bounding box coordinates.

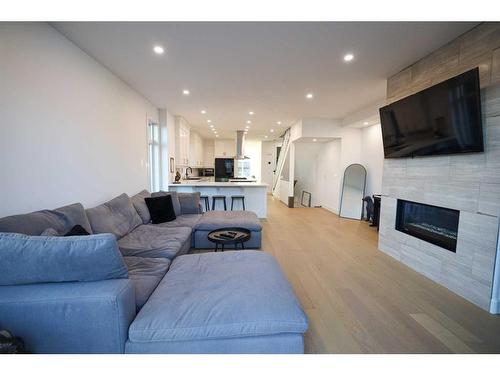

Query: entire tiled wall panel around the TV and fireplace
[379,23,500,310]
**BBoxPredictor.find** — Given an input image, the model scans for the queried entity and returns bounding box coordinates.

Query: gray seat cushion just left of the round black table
[118,225,191,259]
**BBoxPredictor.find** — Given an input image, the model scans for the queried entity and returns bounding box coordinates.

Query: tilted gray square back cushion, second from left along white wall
[87,193,142,238]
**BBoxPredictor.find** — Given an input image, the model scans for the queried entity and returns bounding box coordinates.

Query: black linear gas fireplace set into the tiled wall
[396,199,460,252]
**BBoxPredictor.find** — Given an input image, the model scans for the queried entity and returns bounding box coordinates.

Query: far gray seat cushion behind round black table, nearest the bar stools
[195,211,262,231]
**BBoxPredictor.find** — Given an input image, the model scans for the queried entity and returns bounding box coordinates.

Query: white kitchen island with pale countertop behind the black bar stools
[168,178,267,219]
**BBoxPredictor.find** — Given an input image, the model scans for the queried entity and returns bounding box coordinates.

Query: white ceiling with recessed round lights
[52,22,475,139]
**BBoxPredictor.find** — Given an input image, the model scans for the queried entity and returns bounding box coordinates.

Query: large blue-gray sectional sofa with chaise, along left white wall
[0,191,308,353]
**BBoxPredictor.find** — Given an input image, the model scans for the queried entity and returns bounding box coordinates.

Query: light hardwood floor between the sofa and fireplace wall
[263,197,500,353]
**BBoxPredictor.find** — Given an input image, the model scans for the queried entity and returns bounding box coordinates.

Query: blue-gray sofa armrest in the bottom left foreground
[0,279,136,353]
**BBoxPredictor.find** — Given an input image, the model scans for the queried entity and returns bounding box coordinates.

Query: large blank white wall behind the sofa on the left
[0,23,158,216]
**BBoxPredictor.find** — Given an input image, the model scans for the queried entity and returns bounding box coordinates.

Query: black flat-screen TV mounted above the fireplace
[380,68,484,158]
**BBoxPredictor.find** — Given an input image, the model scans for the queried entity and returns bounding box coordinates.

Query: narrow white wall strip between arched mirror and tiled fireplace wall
[361,124,384,200]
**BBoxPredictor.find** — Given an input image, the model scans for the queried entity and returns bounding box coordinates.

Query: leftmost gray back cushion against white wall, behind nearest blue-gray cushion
[0,203,92,236]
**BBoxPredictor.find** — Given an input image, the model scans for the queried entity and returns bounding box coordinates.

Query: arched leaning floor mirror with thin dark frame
[339,164,366,220]
